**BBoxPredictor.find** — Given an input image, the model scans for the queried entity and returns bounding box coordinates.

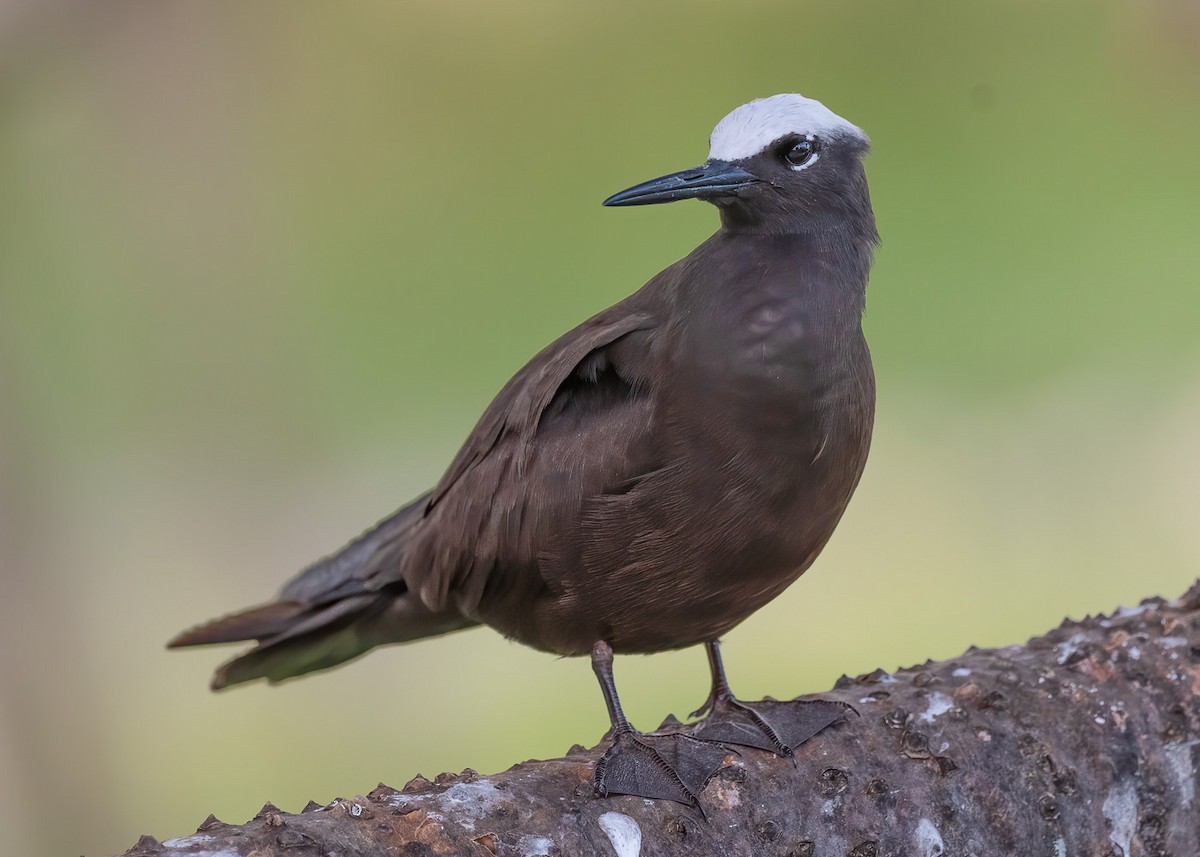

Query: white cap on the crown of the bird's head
[708,94,866,161]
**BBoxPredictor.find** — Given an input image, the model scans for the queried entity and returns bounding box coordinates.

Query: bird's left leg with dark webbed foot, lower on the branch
[592,640,728,807]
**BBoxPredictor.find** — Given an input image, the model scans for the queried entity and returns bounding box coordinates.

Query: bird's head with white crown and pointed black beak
[604,95,870,232]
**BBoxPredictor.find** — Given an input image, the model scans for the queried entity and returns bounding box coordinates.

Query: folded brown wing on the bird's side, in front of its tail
[402,305,655,611]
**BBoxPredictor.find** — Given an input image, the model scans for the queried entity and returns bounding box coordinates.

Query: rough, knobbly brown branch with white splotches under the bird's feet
[127,582,1200,857]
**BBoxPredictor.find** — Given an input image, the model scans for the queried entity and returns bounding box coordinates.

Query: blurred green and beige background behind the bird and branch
[0,0,1200,855]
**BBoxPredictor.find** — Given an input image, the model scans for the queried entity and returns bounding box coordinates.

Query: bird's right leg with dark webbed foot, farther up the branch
[692,640,853,756]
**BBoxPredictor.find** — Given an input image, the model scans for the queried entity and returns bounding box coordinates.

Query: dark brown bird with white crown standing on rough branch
[170,95,878,805]
